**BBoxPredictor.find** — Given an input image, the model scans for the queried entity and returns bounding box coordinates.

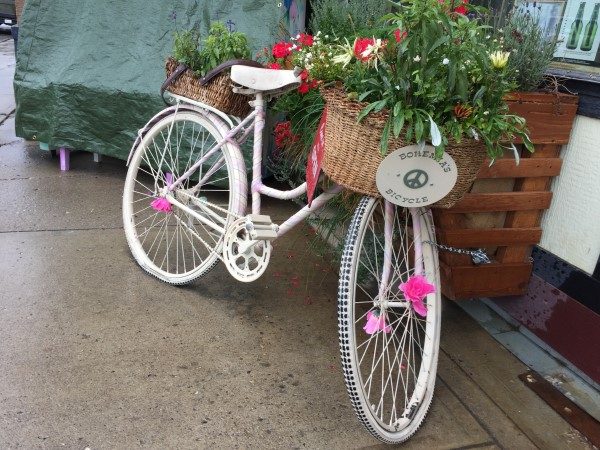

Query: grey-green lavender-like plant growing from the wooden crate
[498,10,557,91]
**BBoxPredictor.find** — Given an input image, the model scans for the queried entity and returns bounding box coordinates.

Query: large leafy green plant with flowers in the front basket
[334,0,533,159]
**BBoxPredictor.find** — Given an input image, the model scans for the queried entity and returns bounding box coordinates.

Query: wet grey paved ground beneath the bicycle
[0,36,589,449]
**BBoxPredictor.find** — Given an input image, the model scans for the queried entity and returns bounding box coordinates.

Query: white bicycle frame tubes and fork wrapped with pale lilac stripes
[138,92,423,296]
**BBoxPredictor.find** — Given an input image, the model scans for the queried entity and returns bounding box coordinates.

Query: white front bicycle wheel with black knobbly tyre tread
[338,197,441,443]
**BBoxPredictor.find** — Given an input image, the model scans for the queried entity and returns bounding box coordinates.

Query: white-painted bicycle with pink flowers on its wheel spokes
[123,59,441,443]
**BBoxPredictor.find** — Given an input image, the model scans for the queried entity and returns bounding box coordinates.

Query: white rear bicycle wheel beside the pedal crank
[123,110,246,284]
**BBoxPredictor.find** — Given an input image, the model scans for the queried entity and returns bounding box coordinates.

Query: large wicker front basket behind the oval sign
[321,88,486,208]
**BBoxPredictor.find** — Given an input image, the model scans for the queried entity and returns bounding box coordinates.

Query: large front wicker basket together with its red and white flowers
[264,0,533,207]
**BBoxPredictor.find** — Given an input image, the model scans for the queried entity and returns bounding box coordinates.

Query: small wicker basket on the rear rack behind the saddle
[166,58,250,117]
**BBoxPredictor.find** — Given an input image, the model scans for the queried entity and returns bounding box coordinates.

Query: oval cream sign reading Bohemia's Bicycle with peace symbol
[376,145,457,207]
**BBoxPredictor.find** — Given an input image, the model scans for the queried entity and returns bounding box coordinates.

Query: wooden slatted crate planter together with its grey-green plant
[435,9,578,299]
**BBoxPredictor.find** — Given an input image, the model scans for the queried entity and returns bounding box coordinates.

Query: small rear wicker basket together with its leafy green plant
[166,22,255,117]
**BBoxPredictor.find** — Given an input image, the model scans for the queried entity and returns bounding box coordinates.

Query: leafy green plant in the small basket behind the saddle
[173,22,250,76]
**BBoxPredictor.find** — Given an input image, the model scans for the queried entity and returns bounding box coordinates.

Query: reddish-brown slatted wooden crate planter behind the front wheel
[434,93,578,300]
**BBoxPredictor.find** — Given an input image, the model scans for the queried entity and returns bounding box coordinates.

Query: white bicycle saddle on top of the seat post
[230,65,301,94]
